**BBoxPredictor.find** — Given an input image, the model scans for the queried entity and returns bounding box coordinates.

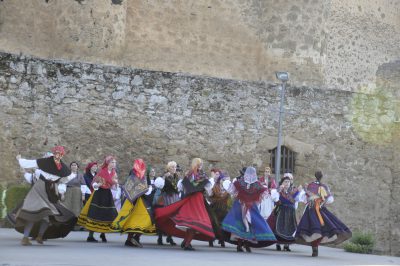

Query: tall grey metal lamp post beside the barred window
[275,72,289,183]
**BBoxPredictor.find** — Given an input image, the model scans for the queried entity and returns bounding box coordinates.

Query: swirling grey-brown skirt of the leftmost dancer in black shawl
[12,179,76,239]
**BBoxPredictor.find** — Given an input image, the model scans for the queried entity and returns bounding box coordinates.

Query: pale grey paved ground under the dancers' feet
[0,228,400,266]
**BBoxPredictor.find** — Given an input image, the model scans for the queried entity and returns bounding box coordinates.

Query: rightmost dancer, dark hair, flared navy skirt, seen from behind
[295,171,352,257]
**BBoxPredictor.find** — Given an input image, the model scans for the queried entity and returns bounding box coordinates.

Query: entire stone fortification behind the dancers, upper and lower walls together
[0,0,400,255]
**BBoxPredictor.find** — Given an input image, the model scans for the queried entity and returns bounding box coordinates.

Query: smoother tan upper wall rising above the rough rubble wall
[0,0,400,91]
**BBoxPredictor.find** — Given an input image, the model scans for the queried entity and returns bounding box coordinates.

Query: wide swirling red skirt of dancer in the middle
[155,192,215,241]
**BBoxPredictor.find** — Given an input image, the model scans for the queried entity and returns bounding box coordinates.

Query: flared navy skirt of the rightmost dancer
[296,206,352,245]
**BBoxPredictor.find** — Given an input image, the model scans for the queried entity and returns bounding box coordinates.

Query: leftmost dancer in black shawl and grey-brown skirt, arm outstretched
[15,146,76,246]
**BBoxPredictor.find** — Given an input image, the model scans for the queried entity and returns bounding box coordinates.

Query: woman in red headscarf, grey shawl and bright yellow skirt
[112,159,156,247]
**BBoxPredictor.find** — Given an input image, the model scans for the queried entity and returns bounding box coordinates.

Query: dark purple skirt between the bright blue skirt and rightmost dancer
[268,205,297,244]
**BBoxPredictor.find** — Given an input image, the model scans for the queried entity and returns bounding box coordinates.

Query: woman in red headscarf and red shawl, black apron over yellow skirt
[78,156,118,242]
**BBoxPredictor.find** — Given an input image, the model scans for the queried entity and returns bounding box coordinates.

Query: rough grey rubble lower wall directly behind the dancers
[0,53,400,255]
